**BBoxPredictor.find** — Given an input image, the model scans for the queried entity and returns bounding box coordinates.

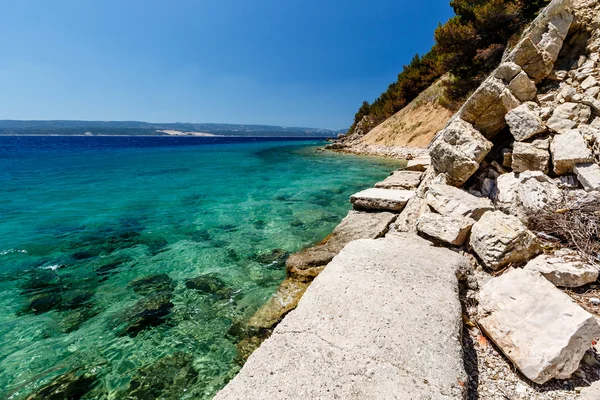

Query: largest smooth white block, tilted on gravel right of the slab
[479,269,600,384]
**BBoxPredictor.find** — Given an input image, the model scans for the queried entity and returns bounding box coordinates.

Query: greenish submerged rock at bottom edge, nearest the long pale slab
[116,352,198,400]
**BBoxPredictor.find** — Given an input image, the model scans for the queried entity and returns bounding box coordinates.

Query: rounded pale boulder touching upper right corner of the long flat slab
[469,211,541,270]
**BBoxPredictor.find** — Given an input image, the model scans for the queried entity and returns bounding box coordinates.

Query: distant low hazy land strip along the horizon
[0,120,345,137]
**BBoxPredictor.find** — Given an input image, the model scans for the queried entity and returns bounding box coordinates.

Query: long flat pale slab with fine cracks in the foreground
[215,235,467,400]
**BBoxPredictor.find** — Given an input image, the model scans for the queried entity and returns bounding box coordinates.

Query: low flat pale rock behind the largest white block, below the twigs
[525,249,598,287]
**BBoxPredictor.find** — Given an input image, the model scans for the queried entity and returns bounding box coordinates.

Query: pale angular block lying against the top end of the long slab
[417,213,475,246]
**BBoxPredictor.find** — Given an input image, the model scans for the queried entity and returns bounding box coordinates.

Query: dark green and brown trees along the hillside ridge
[349,0,549,134]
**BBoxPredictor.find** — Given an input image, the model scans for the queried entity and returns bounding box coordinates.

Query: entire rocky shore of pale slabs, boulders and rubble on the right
[216,0,600,400]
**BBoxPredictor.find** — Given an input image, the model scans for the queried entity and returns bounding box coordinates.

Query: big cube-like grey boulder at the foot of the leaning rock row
[429,118,492,186]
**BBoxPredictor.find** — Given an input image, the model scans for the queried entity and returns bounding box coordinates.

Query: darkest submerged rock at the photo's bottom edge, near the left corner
[27,370,97,400]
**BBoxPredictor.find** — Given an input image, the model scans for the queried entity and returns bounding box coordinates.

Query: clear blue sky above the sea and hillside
[0,0,452,129]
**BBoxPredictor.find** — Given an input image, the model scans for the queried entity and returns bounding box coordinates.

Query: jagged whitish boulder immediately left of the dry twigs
[495,171,563,222]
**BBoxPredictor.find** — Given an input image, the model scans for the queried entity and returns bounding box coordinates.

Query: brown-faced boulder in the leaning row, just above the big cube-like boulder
[458,77,521,139]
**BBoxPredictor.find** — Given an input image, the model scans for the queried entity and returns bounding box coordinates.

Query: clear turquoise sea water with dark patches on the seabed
[0,137,398,399]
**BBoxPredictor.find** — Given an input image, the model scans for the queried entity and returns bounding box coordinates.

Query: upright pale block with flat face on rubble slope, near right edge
[550,129,594,175]
